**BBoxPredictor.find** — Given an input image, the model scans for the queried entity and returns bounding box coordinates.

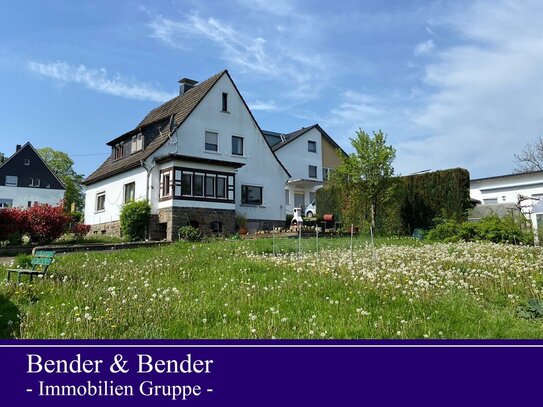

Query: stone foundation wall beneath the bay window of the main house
[156,206,236,240]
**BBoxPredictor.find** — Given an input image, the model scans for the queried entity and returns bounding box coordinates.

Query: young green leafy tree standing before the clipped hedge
[333,129,396,230]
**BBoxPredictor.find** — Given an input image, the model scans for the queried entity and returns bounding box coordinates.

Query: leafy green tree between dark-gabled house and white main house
[38,147,85,212]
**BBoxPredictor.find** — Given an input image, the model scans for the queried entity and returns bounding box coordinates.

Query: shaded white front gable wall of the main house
[176,75,288,222]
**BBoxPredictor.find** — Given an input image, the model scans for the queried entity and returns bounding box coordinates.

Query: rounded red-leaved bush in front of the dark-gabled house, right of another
[25,204,72,244]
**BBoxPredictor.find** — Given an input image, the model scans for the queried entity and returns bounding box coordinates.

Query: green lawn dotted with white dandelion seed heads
[0,237,543,339]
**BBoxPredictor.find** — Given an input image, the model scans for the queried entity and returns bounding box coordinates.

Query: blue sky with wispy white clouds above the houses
[0,0,543,177]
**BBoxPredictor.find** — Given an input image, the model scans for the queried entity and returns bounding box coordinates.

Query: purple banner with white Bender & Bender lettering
[0,341,543,407]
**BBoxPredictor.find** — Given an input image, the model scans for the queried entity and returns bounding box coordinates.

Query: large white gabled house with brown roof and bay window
[84,70,289,240]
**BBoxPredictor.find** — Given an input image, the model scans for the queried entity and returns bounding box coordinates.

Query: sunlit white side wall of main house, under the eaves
[85,167,148,228]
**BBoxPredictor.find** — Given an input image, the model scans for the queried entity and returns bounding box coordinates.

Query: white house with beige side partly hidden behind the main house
[264,124,346,217]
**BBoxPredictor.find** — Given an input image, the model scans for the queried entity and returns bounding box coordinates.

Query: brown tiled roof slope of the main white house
[84,70,227,185]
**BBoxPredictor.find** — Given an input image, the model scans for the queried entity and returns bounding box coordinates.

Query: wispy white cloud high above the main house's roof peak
[148,15,333,100]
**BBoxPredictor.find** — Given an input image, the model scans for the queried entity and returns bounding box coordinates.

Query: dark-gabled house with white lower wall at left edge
[0,143,65,208]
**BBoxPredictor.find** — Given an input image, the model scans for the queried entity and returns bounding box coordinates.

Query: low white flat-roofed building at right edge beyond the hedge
[470,171,543,215]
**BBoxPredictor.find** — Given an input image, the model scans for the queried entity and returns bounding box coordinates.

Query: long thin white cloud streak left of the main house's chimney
[28,61,176,102]
